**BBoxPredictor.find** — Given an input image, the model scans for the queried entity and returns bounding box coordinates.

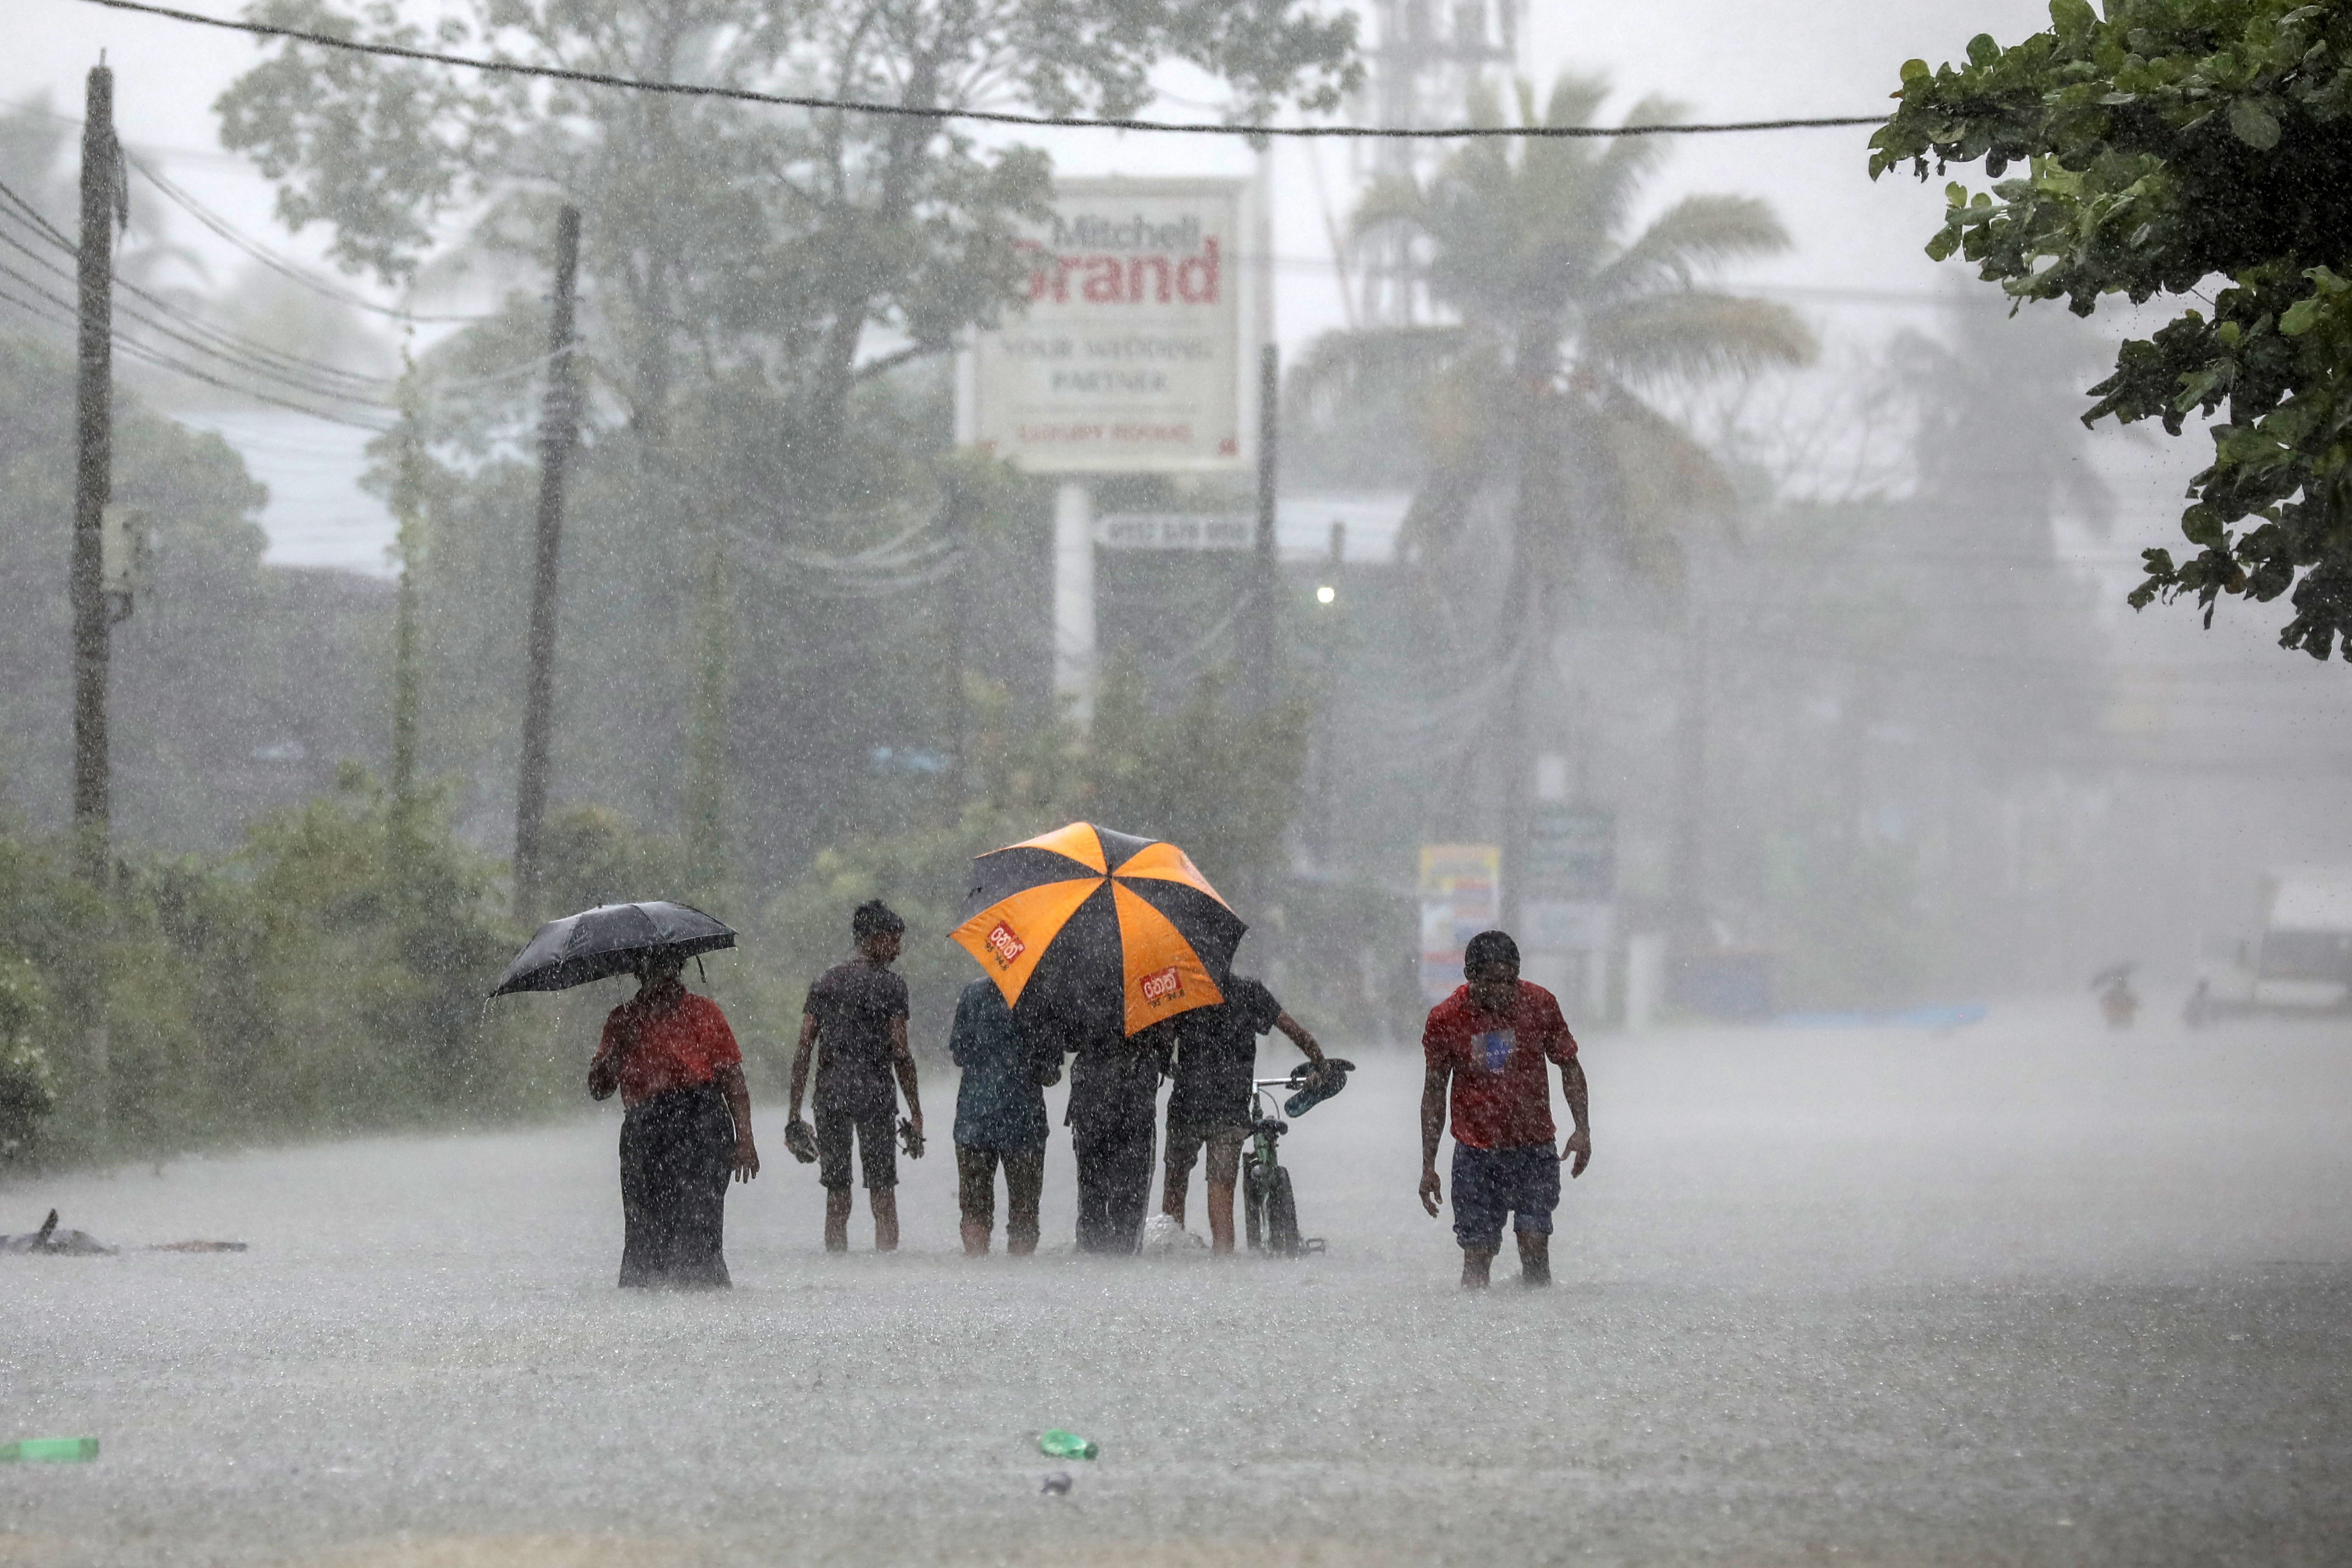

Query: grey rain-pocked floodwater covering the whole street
[0,997,2352,1568]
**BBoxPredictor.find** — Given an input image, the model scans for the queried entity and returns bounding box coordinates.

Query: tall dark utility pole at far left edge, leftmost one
[68,66,122,889]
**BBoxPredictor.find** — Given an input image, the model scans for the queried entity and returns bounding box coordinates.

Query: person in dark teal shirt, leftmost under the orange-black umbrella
[948,980,1061,1258]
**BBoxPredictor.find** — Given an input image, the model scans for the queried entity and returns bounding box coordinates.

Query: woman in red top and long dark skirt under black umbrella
[588,952,760,1288]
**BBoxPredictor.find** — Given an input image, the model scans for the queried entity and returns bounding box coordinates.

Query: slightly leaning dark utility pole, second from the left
[515,204,581,919]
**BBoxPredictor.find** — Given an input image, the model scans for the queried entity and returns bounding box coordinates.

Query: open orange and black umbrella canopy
[950,823,1249,1034]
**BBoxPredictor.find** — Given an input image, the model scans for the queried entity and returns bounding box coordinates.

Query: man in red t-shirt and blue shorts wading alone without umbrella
[1421,931,1592,1290]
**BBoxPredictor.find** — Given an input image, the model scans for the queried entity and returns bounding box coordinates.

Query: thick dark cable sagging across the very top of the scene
[69,0,1886,141]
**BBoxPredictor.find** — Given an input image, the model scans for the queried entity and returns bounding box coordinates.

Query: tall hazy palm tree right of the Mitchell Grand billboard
[1294,75,1813,919]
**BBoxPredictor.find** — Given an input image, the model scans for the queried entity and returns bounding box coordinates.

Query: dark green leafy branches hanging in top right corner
[1870,0,2352,658]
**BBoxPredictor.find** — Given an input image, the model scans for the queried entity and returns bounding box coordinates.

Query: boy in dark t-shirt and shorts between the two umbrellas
[790,898,922,1253]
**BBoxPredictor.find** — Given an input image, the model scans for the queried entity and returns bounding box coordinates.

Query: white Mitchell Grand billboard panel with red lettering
[955,178,1263,475]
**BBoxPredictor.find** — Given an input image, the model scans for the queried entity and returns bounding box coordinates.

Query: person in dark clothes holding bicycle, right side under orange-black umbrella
[1160,975,1324,1253]
